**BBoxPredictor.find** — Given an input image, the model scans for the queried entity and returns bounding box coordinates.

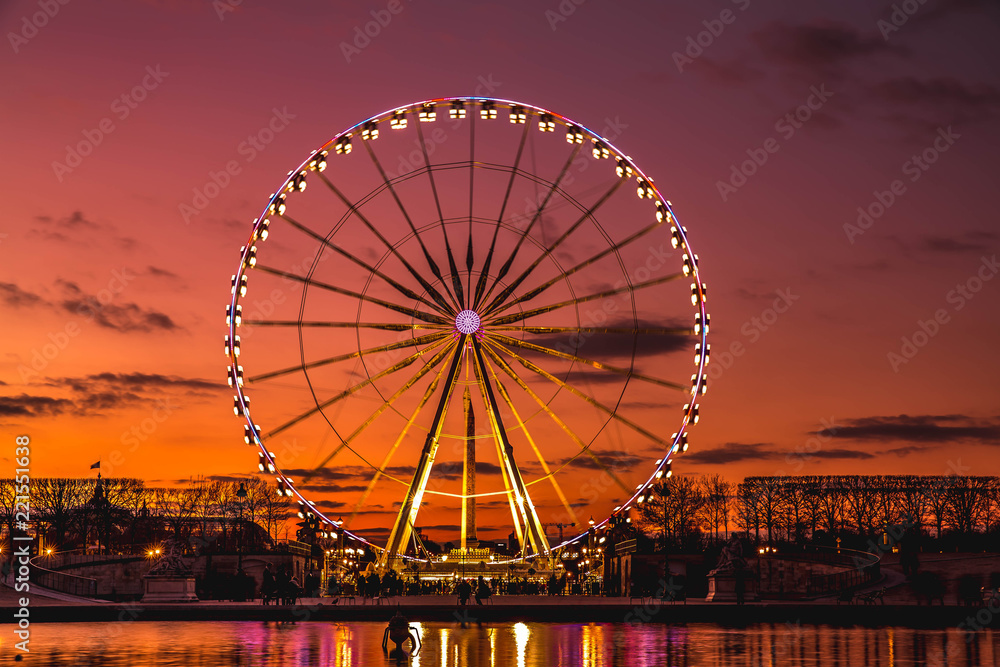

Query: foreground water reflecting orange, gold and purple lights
[7,621,1000,667]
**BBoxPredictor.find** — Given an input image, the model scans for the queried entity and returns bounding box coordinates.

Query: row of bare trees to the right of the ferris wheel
[638,475,1000,548]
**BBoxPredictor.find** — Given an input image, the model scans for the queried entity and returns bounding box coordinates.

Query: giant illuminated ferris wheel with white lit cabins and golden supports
[226,98,709,565]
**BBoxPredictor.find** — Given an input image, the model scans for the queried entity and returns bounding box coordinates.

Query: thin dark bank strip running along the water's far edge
[0,601,1000,630]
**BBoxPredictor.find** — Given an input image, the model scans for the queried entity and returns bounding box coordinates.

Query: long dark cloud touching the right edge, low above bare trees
[814,414,1000,446]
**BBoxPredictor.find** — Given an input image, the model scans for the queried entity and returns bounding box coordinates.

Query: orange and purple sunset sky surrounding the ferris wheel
[0,0,1000,537]
